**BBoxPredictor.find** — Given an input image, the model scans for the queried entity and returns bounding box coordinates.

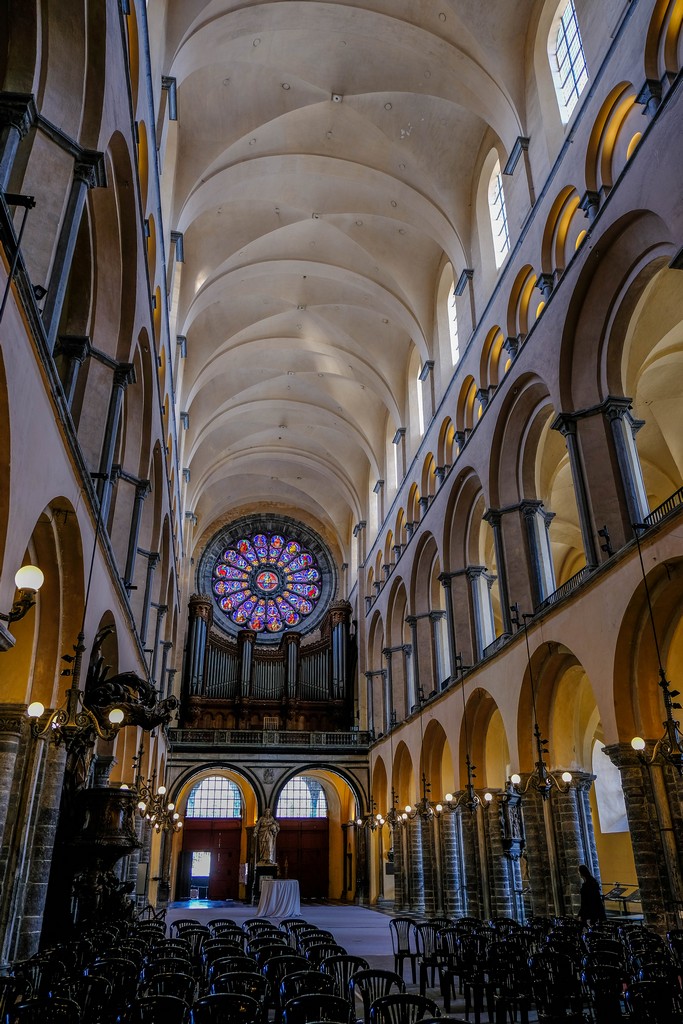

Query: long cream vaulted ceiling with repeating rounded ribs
[158,0,528,551]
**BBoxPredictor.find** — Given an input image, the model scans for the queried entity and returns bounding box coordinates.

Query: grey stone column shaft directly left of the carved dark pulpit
[16,742,67,959]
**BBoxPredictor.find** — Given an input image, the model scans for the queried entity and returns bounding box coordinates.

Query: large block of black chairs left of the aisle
[0,919,473,1024]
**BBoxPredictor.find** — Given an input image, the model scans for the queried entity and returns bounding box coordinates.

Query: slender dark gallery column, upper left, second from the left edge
[43,150,105,350]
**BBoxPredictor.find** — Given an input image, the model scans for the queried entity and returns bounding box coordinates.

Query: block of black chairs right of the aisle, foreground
[390,916,683,1024]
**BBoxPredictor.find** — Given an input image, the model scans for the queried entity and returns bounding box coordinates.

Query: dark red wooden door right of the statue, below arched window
[276,818,330,899]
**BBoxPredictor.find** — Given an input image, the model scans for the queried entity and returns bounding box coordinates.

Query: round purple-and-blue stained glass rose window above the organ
[211,534,321,633]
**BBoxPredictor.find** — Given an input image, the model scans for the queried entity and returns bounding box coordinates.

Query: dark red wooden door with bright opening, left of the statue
[175,818,242,900]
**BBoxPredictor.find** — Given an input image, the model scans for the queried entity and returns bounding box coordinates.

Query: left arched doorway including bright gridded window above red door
[175,775,244,900]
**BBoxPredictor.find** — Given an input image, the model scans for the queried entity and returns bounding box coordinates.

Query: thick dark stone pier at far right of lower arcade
[604,739,683,933]
